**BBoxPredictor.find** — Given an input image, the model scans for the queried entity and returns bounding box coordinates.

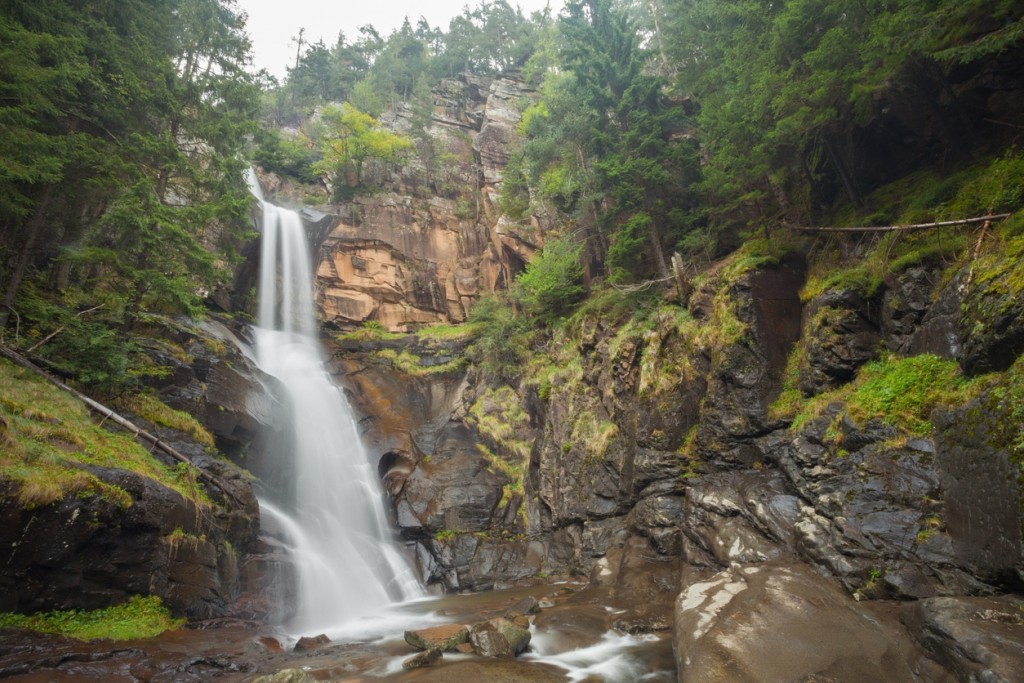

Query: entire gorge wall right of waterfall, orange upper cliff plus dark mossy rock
[247,73,1024,680]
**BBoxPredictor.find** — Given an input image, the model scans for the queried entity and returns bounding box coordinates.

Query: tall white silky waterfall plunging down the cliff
[250,174,422,633]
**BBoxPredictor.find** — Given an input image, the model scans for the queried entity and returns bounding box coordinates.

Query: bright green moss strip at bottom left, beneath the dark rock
[0,596,184,640]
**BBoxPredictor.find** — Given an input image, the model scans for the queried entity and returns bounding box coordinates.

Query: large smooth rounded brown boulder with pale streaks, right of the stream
[675,565,951,683]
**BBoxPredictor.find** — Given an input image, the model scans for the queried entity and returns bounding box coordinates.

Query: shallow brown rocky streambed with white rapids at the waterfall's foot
[0,584,676,683]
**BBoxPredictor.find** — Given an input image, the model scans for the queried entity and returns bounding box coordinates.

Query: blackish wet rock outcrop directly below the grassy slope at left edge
[0,458,251,620]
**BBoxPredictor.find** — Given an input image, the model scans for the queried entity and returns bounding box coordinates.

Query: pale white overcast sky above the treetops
[237,0,562,78]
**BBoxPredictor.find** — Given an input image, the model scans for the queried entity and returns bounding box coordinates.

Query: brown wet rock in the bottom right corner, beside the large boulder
[907,596,1024,683]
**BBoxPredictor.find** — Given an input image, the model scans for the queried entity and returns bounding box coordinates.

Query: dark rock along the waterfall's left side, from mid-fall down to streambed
[0,321,280,620]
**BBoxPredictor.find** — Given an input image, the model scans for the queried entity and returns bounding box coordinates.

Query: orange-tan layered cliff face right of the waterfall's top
[253,75,539,331]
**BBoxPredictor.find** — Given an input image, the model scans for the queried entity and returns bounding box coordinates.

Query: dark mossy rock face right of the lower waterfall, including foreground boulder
[331,237,1024,681]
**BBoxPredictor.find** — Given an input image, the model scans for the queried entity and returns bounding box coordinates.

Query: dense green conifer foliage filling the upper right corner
[663,0,1024,229]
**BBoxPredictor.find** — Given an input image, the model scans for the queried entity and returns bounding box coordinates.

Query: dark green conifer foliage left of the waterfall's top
[0,0,258,391]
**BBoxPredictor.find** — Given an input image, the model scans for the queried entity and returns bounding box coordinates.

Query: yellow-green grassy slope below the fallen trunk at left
[0,360,210,508]
